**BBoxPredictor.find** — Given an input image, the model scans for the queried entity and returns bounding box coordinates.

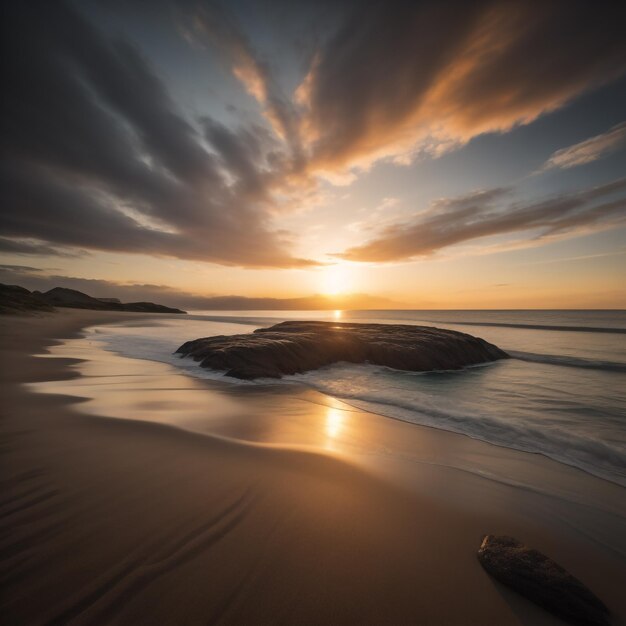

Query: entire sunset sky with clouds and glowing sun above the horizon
[0,0,626,309]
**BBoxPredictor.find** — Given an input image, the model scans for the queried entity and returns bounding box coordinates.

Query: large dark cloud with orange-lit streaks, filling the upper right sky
[298,0,626,170]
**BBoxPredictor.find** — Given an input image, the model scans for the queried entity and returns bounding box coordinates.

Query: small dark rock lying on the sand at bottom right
[478,535,610,626]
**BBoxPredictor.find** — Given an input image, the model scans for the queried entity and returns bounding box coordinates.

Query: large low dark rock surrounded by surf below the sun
[176,322,507,379]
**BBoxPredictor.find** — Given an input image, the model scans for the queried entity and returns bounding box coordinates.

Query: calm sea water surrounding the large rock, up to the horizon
[91,310,626,485]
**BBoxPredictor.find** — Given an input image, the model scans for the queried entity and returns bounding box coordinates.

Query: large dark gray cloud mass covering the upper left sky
[0,0,308,267]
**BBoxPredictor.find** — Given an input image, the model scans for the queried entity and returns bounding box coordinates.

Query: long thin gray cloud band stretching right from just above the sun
[336,178,626,262]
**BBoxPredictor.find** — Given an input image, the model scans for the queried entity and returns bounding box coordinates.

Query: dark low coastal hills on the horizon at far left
[0,283,185,314]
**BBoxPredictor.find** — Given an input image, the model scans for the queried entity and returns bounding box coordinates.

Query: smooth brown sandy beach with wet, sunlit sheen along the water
[0,309,626,625]
